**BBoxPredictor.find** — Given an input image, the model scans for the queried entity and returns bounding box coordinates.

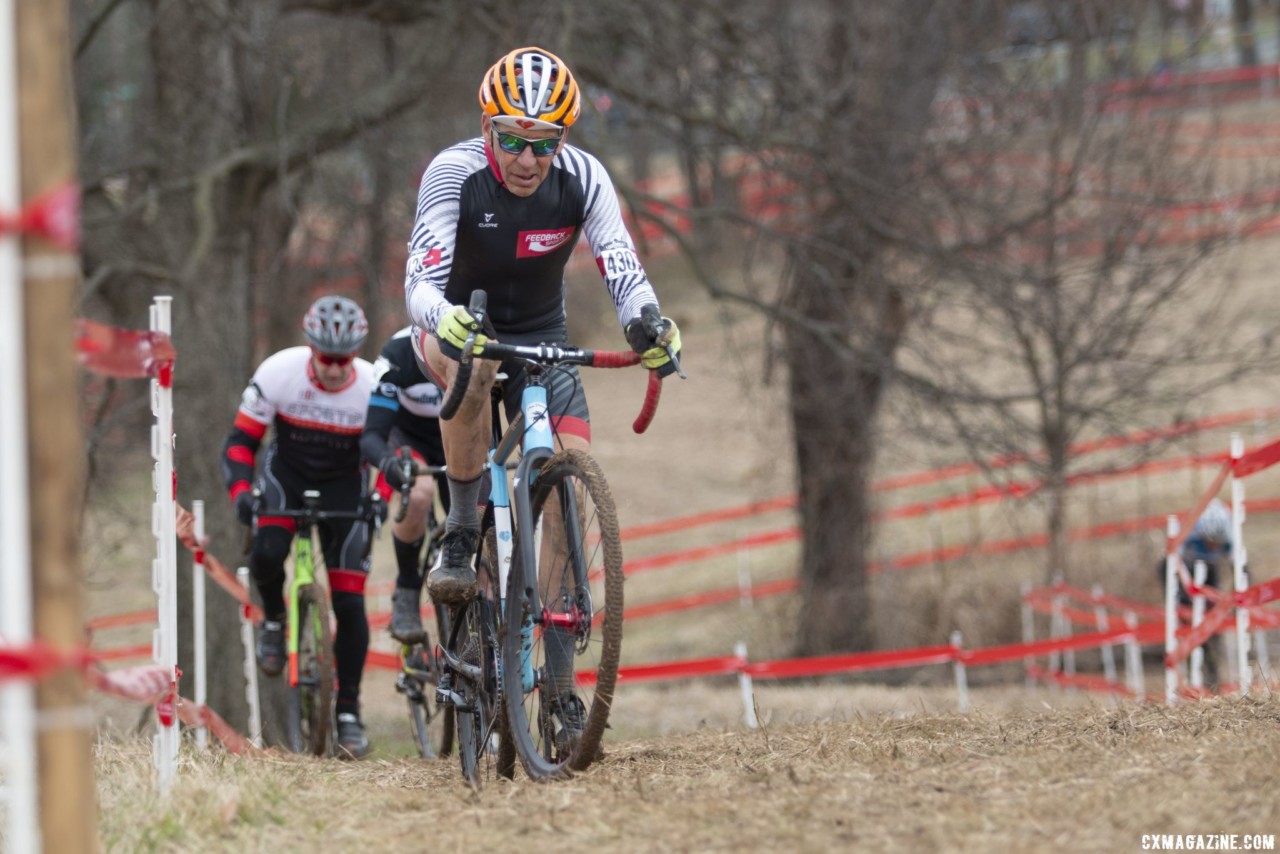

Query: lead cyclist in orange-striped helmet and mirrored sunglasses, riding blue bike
[404,47,680,742]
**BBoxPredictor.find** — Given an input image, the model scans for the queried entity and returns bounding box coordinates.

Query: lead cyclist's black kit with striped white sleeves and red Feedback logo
[404,137,658,438]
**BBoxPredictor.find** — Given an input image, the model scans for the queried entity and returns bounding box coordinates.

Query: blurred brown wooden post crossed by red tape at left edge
[17,0,97,851]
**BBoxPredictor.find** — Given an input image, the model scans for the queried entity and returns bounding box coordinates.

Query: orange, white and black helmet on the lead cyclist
[480,47,582,131]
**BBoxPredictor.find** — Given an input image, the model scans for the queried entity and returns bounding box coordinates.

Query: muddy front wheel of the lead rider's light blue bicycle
[502,449,622,780]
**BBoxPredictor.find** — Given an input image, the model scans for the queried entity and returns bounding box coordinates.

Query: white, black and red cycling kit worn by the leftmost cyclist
[223,347,374,711]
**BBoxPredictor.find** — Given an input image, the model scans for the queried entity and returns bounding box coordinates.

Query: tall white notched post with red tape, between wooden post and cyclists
[151,297,179,794]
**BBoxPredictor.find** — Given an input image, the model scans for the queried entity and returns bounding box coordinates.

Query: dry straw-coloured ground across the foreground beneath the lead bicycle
[100,697,1280,853]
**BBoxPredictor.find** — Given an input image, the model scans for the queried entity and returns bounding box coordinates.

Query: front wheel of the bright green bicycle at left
[288,584,333,757]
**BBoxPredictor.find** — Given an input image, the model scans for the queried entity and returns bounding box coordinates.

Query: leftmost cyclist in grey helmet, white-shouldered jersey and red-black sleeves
[223,296,374,757]
